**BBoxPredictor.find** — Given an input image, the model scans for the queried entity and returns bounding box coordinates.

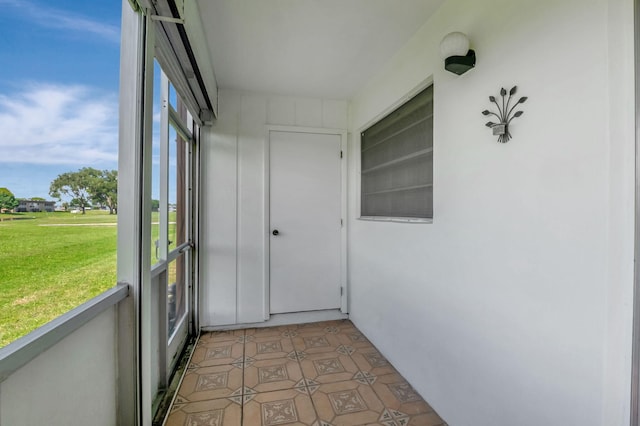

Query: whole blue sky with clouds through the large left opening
[0,0,121,199]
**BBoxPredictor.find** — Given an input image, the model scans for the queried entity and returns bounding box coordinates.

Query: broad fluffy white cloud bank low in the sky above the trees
[0,84,118,166]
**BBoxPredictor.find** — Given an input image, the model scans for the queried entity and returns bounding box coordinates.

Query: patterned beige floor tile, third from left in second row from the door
[300,352,359,383]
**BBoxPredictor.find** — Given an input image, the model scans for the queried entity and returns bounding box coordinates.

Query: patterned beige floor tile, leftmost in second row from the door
[178,365,243,402]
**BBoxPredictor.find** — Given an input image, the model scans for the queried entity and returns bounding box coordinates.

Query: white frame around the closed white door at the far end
[263,125,349,321]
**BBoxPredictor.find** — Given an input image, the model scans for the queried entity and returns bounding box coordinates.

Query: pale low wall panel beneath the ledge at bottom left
[0,307,117,426]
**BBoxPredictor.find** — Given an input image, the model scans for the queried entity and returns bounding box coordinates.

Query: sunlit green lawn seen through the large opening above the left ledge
[0,211,117,347]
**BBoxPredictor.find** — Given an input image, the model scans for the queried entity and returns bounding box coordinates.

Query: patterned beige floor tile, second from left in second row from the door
[244,358,304,392]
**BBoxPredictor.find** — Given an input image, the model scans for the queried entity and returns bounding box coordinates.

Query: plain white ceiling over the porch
[197,0,444,99]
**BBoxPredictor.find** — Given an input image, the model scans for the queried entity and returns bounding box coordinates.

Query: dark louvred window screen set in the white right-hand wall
[361,86,433,219]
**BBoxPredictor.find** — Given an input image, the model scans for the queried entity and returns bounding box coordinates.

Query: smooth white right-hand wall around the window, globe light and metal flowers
[349,0,634,426]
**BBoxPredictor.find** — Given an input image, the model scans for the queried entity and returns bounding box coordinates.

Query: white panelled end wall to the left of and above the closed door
[200,90,347,327]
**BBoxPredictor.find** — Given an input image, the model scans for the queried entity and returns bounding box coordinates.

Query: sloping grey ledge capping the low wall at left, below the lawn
[0,284,129,382]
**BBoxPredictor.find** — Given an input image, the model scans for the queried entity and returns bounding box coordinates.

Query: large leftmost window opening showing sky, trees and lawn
[0,1,121,346]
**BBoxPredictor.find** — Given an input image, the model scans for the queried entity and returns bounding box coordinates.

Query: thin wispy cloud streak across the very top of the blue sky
[0,0,120,43]
